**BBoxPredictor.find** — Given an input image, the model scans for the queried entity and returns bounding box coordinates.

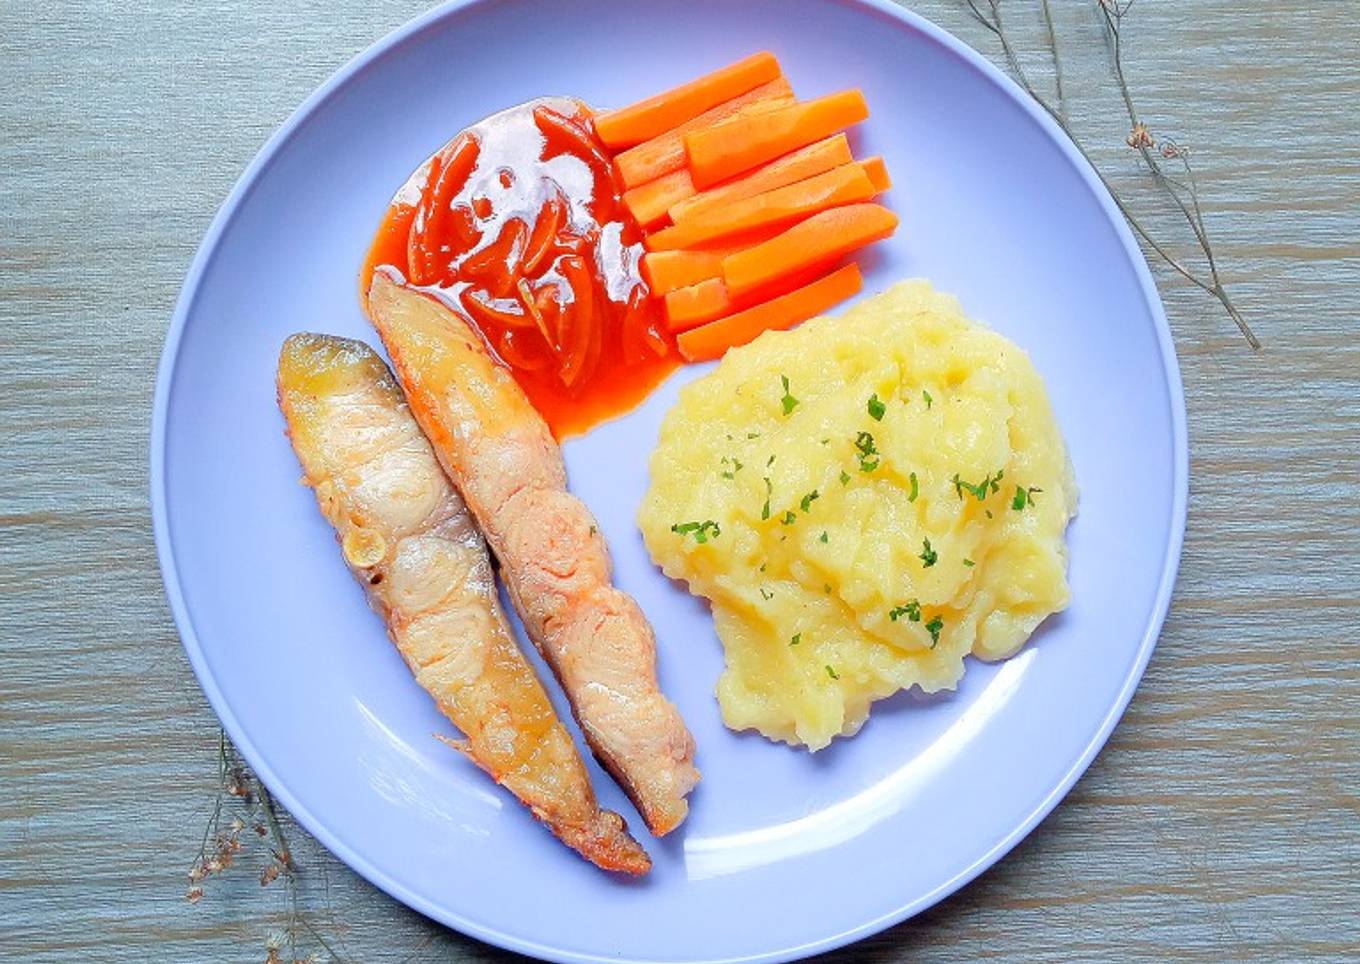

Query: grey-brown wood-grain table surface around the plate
[0,0,1360,963]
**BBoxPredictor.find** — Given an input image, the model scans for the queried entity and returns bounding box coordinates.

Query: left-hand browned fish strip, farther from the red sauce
[279,334,651,874]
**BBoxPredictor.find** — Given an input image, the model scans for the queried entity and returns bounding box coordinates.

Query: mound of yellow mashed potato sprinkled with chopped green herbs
[638,281,1077,749]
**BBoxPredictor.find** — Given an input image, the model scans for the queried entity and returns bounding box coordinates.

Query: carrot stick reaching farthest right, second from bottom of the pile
[722,204,898,296]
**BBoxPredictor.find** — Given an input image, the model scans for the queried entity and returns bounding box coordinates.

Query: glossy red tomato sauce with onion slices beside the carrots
[359,98,680,439]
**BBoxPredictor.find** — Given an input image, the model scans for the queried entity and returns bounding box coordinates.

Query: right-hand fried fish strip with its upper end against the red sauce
[369,272,699,835]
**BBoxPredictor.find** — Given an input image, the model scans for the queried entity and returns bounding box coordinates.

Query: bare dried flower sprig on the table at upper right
[964,0,1261,348]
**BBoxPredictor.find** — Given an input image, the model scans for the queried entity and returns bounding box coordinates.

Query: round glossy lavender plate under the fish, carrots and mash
[151,0,1187,961]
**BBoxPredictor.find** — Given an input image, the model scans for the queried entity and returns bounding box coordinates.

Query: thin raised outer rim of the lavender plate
[148,0,1190,964]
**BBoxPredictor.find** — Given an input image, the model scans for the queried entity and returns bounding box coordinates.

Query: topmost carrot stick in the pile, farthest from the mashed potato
[594,50,779,150]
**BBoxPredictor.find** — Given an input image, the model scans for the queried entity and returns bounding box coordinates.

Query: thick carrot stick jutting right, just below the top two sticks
[684,90,869,189]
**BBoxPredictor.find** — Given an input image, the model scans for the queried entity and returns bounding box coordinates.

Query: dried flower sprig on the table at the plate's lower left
[185,731,345,964]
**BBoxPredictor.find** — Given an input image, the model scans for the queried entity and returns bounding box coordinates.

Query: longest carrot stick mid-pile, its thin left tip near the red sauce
[646,165,874,252]
